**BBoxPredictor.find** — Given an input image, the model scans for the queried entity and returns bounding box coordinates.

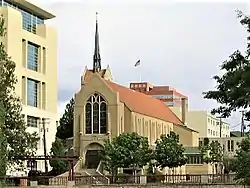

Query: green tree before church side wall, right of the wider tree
[154,131,187,173]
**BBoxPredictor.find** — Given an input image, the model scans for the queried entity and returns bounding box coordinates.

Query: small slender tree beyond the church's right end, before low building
[201,141,223,174]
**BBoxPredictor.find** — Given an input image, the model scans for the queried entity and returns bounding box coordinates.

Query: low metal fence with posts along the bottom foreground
[0,174,236,187]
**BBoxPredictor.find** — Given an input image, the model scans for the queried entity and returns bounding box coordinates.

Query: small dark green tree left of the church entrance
[50,138,68,175]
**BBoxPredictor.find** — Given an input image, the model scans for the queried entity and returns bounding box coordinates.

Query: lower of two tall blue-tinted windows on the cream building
[27,79,38,107]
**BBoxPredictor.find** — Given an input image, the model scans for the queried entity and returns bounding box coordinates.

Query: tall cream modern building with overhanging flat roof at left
[0,0,59,175]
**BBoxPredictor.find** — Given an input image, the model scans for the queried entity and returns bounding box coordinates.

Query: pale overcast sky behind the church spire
[32,0,247,127]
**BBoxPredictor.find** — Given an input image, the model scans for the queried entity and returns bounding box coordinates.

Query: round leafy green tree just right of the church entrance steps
[103,133,152,175]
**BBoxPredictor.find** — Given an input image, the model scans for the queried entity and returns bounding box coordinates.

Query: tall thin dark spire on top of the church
[93,13,101,72]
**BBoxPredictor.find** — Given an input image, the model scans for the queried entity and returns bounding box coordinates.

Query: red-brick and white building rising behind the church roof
[130,82,188,107]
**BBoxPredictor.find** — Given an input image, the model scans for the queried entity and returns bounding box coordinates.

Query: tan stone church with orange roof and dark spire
[74,13,198,169]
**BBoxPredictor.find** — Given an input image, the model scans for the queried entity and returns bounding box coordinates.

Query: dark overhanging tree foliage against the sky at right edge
[204,11,250,119]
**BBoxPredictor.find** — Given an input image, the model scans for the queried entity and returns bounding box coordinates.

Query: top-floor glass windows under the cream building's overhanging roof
[0,0,44,33]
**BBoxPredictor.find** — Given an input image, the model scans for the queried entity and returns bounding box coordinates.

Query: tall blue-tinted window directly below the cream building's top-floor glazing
[27,43,38,71]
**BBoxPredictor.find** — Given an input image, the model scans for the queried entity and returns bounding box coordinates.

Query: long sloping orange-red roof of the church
[105,80,183,125]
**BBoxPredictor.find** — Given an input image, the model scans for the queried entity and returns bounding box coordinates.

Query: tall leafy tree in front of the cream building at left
[0,17,39,167]
